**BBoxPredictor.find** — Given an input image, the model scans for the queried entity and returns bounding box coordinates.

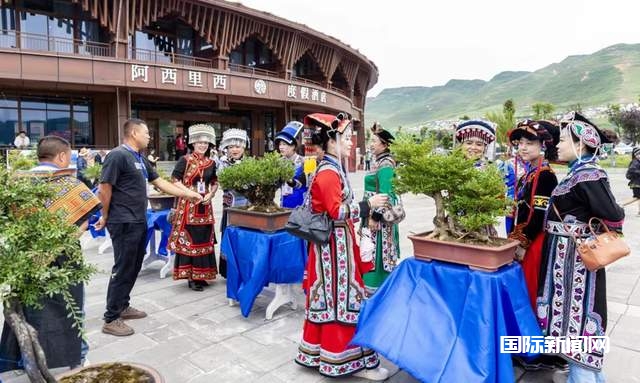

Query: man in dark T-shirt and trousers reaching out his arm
[95,119,202,336]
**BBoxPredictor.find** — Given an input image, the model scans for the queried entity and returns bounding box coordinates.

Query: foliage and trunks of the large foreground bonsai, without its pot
[391,136,512,243]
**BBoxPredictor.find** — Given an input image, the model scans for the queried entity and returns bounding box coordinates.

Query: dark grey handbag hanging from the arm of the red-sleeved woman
[284,164,333,245]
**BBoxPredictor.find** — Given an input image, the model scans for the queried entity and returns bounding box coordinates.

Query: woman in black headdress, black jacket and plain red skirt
[508,120,560,310]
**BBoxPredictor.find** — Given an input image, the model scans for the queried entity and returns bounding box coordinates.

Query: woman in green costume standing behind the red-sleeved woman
[362,123,400,296]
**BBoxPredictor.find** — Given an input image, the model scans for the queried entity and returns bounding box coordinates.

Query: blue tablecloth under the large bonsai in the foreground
[353,258,542,383]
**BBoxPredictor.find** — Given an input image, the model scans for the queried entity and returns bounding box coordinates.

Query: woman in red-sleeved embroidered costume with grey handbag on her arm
[295,113,388,380]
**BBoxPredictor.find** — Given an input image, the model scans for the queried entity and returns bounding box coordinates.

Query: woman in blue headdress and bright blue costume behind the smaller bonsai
[275,121,307,209]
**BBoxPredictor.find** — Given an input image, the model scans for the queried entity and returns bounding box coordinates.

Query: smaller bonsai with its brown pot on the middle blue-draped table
[218,152,294,231]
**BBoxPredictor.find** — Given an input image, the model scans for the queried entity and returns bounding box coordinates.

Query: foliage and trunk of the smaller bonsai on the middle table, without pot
[218,152,295,213]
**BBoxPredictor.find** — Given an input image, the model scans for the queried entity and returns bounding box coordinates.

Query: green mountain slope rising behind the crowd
[366,44,640,127]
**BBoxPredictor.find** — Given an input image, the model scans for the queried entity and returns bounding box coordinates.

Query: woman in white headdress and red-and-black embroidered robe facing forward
[169,124,218,291]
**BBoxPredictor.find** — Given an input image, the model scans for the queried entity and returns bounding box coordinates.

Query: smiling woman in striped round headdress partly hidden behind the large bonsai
[456,120,516,236]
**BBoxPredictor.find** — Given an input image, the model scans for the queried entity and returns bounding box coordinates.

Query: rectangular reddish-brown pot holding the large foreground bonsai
[409,232,519,271]
